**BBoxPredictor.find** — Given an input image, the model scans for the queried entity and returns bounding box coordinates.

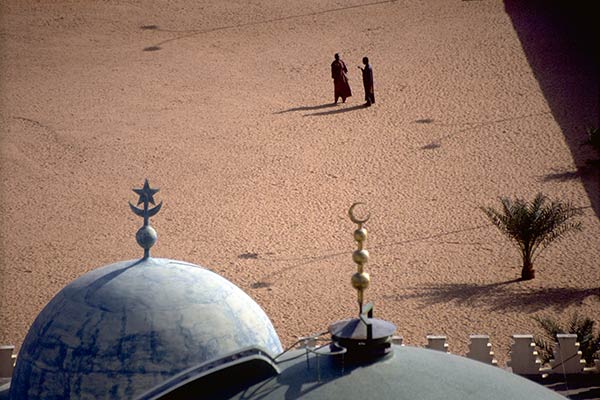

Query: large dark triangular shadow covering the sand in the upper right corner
[504,0,600,216]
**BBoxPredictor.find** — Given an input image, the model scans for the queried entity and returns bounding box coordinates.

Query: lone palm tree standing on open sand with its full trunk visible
[481,193,581,280]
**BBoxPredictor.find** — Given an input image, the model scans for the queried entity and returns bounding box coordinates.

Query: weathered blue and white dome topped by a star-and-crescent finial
[10,258,282,399]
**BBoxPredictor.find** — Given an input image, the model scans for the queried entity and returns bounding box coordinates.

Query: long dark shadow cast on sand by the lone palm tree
[386,279,600,312]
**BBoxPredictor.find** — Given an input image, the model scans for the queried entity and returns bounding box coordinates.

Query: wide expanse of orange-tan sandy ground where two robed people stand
[0,0,600,372]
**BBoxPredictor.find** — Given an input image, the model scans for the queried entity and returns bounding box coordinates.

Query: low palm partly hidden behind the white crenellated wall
[533,312,600,365]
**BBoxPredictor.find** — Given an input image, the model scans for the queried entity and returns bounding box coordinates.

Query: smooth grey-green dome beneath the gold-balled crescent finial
[156,345,565,400]
